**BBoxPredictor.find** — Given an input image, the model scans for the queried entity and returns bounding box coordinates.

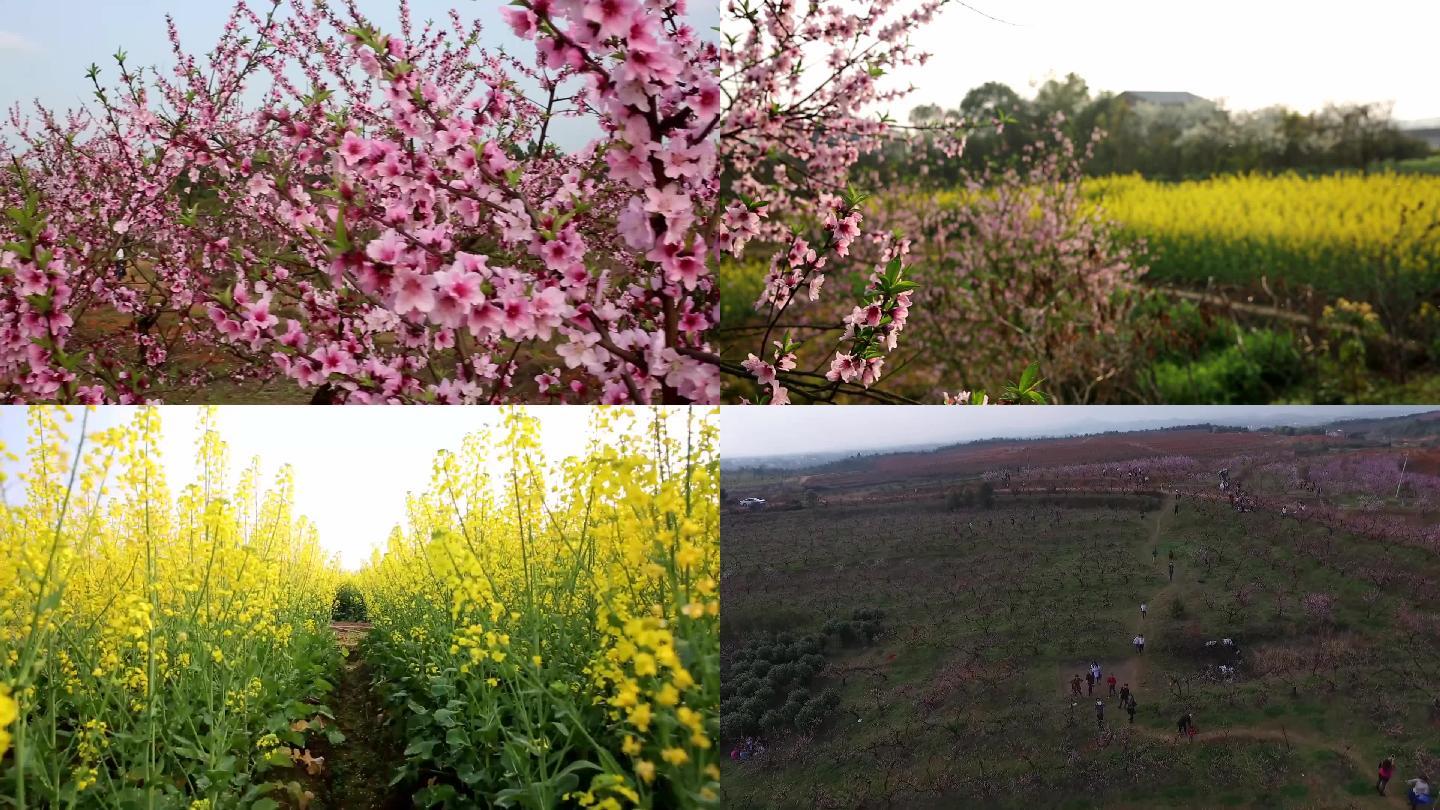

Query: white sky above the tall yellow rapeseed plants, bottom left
[0,405,696,569]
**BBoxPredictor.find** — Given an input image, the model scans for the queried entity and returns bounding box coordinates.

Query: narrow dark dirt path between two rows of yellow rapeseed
[311,623,410,810]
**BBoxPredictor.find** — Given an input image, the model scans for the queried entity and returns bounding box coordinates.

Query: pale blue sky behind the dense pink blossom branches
[0,0,719,148]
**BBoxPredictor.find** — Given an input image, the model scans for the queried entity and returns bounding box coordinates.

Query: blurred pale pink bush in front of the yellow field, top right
[873,121,1149,402]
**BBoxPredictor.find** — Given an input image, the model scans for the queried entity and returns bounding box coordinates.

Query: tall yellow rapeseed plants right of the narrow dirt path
[359,411,720,810]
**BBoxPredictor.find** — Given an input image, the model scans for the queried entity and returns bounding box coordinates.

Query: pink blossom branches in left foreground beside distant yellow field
[714,0,1045,404]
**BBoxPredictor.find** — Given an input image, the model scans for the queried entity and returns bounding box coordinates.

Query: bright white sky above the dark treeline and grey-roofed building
[888,0,1440,120]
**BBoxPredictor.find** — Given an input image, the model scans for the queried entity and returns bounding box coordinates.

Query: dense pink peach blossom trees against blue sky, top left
[0,0,720,402]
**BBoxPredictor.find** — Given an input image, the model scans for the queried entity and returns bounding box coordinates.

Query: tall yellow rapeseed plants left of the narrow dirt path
[0,408,343,809]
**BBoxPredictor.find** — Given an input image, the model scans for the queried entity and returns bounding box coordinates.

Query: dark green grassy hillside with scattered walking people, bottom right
[723,434,1440,809]
